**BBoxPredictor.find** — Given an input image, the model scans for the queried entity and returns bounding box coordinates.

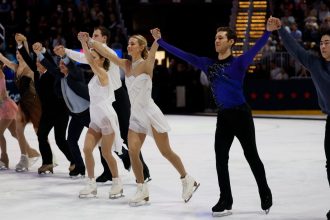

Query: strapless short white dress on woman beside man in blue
[125,73,170,136]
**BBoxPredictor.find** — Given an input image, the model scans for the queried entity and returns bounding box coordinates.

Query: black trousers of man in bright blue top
[214,104,269,201]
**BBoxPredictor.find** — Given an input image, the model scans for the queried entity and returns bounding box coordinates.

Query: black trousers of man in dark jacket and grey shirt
[68,108,91,168]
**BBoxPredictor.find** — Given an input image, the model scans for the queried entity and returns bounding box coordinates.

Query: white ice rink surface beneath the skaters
[0,115,330,220]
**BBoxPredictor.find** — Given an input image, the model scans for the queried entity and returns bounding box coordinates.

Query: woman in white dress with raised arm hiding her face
[78,34,123,198]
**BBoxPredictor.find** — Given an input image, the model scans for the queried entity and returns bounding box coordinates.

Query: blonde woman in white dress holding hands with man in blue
[85,31,199,206]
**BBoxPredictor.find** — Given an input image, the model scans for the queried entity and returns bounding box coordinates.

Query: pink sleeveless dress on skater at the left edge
[0,78,18,119]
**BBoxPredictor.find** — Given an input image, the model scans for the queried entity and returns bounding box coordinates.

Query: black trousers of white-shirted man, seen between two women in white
[112,85,149,172]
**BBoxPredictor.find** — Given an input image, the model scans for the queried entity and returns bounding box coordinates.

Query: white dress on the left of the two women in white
[88,75,123,154]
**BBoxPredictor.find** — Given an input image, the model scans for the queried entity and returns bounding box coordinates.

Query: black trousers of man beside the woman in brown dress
[37,112,73,165]
